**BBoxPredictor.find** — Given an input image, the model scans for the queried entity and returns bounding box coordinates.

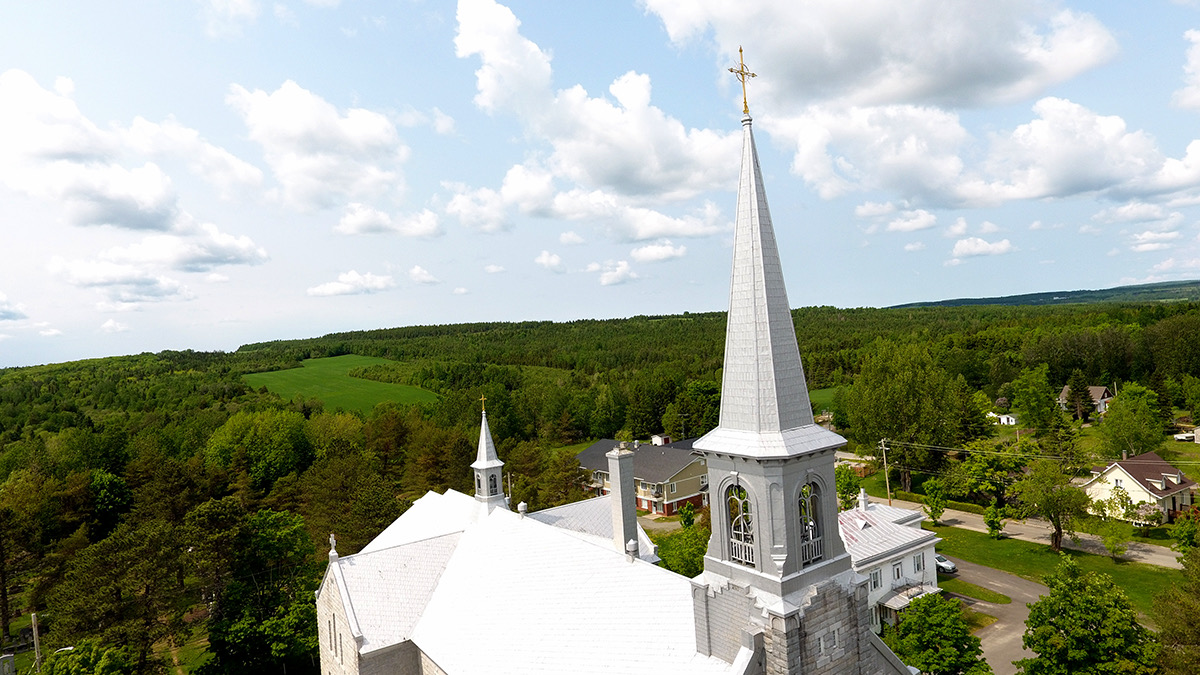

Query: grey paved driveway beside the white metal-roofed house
[947,557,1049,675]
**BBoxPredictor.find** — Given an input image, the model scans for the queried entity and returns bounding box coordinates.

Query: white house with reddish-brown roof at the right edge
[1084,453,1196,521]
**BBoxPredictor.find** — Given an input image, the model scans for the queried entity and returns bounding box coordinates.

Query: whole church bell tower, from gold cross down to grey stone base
[692,47,894,675]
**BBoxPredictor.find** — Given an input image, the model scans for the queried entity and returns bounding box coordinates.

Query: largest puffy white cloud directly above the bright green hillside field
[226,80,408,209]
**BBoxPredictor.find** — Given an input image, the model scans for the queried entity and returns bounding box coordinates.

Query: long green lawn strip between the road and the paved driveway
[924,522,1183,615]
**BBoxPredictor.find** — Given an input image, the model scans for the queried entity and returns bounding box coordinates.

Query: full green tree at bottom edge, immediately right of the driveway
[1016,555,1158,675]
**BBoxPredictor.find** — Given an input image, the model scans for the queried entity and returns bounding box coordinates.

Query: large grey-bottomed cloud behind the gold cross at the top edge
[644,0,1117,109]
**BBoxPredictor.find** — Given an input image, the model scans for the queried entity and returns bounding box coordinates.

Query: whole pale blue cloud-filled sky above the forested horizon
[0,0,1200,366]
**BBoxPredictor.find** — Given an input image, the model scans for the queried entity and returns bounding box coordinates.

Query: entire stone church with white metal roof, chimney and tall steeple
[317,60,912,675]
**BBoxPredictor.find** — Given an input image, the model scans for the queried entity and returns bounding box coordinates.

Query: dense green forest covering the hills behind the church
[0,296,1200,673]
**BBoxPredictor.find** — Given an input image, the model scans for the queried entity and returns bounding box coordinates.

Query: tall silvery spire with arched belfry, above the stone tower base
[692,99,850,597]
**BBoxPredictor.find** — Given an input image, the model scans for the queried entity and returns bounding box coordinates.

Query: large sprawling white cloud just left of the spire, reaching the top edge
[446,0,740,239]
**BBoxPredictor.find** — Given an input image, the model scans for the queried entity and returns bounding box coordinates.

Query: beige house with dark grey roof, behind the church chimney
[578,438,708,515]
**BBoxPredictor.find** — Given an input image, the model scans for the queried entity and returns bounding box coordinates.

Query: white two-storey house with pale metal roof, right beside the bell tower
[838,490,941,632]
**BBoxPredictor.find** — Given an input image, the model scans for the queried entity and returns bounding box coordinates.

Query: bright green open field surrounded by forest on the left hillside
[244,354,438,414]
